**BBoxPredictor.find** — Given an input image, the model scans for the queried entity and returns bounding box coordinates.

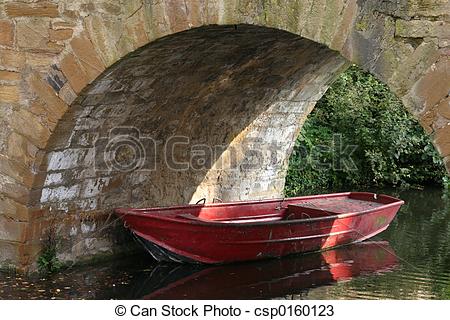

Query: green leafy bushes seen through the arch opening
[285,66,448,196]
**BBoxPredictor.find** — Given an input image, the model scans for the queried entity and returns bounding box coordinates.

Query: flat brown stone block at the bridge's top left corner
[5,1,59,18]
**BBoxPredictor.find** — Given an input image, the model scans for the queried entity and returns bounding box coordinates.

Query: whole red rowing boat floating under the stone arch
[115,192,404,264]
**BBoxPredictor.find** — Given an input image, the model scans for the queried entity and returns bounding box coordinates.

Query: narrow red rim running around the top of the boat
[114,192,405,228]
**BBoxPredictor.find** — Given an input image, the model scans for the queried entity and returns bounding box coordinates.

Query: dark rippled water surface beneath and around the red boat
[0,189,450,299]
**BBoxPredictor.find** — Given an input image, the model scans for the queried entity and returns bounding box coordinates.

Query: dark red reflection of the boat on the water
[136,241,398,299]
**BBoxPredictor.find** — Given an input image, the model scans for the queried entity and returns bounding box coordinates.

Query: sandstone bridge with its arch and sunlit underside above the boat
[0,0,450,269]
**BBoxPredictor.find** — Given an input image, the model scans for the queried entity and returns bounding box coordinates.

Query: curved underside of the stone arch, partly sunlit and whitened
[31,25,347,260]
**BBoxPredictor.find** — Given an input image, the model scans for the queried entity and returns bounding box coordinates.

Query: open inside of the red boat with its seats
[118,192,400,223]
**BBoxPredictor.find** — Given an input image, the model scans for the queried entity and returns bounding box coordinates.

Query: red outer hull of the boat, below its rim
[118,193,403,264]
